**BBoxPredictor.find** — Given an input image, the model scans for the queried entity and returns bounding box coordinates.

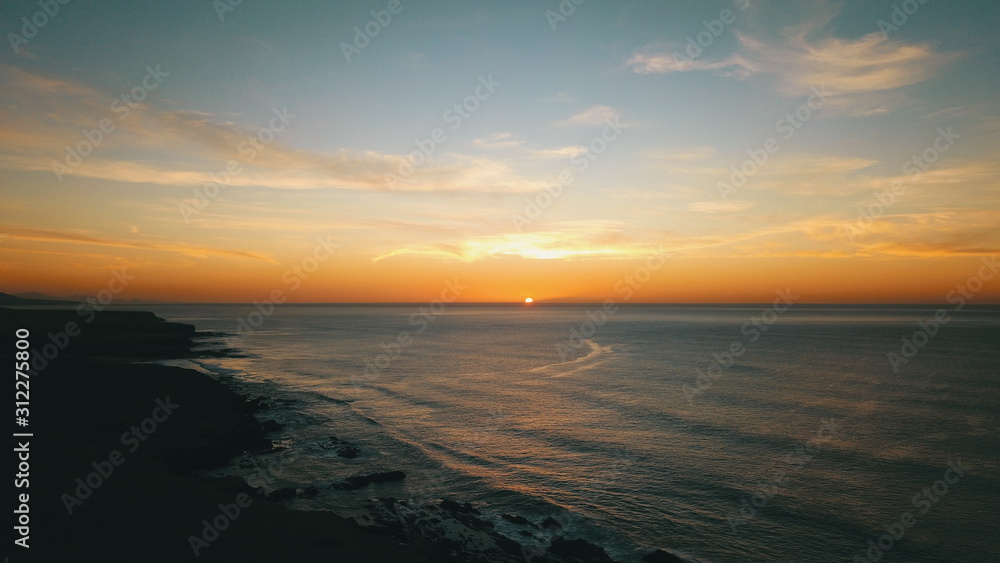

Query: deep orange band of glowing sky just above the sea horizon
[0,251,1000,305]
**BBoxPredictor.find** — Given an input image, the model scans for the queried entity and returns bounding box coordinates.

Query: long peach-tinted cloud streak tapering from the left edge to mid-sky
[0,68,545,193]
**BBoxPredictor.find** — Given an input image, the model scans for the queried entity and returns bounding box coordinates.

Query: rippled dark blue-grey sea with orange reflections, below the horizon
[121,304,1000,562]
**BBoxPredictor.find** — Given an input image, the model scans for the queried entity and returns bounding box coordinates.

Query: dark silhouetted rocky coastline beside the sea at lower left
[0,308,681,563]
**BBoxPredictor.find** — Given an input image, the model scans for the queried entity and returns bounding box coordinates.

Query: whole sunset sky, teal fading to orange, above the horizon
[0,0,1000,303]
